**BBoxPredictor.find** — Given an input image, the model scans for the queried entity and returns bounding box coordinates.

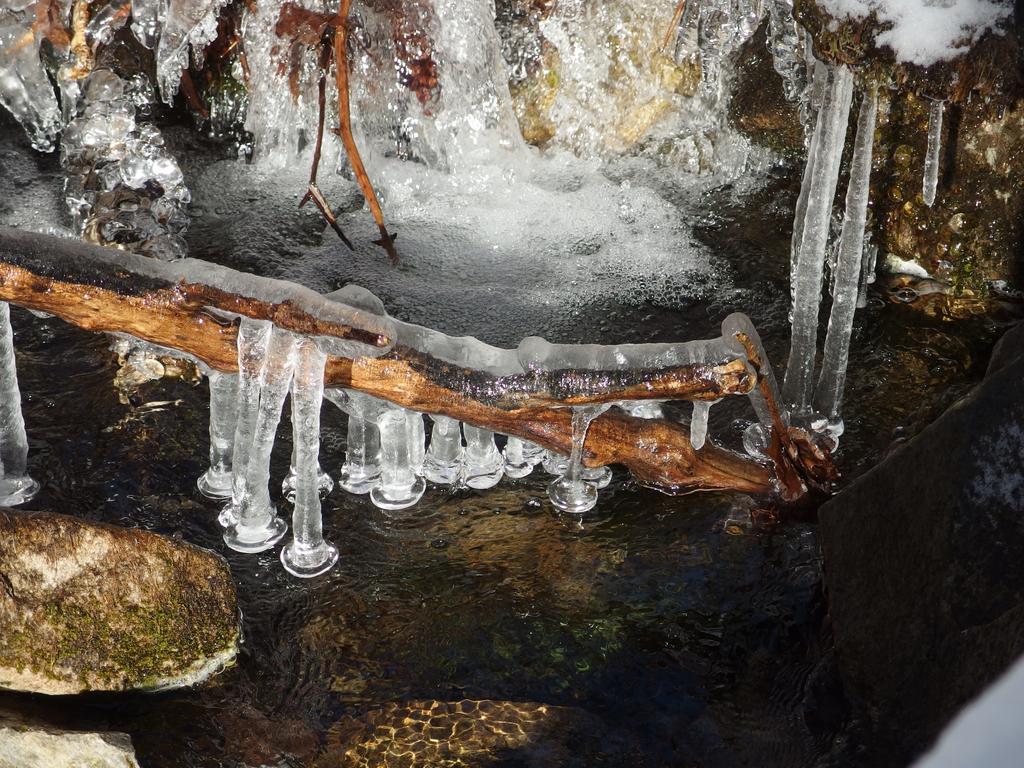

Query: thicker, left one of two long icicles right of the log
[783,66,853,414]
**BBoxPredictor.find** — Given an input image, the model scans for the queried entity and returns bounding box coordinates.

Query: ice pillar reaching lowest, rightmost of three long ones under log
[281,338,338,579]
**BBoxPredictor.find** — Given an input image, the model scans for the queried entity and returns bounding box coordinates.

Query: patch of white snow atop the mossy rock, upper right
[821,0,1013,67]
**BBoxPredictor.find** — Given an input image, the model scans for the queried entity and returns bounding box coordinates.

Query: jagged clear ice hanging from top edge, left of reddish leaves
[157,0,233,104]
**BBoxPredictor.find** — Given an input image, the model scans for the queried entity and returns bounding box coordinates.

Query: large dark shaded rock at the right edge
[820,326,1024,752]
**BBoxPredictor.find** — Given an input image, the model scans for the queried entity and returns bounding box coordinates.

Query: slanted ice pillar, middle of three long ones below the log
[224,326,296,552]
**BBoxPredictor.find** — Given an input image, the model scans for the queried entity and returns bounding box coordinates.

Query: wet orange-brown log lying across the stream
[0,228,775,494]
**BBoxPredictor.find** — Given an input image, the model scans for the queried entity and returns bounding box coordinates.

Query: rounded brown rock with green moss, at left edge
[0,510,239,694]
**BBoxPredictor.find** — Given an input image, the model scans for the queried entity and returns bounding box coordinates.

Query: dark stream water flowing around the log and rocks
[0,115,991,768]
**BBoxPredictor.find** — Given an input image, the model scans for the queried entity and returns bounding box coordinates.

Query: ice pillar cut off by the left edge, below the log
[0,301,39,507]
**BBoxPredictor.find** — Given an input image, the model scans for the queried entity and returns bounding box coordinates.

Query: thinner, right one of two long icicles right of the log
[814,87,878,437]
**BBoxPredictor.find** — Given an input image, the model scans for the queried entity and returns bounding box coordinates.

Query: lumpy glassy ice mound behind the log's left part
[60,70,189,260]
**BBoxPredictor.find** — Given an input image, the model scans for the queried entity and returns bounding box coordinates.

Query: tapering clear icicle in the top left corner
[0,9,62,152]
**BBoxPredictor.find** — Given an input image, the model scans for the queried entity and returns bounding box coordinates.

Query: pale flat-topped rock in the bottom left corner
[0,720,138,768]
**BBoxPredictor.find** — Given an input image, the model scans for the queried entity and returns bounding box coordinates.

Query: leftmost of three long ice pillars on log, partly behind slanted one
[219,317,272,528]
